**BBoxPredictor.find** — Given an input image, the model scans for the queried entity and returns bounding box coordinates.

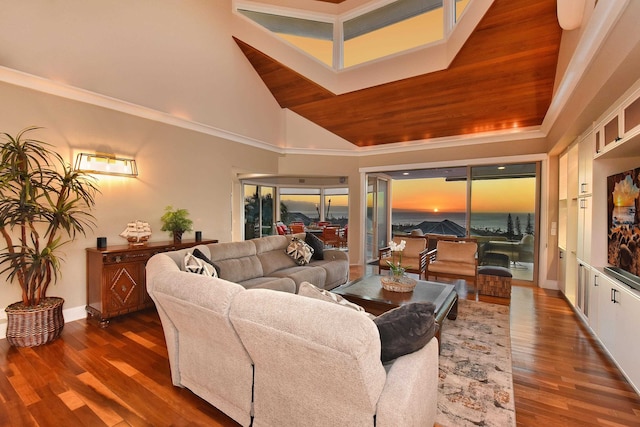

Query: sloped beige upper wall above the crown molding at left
[0,0,282,145]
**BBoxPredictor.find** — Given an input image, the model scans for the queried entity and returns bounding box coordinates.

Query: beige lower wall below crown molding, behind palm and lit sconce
[0,83,278,328]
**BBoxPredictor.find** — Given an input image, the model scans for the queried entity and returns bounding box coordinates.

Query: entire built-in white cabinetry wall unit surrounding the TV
[558,80,640,392]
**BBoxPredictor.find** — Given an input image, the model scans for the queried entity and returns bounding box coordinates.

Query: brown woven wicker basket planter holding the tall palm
[5,297,64,347]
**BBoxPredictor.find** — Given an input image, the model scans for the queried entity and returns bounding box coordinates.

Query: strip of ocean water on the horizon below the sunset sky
[391,211,535,233]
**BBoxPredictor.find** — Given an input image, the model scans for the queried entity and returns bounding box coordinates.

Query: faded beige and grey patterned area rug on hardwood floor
[436,299,516,427]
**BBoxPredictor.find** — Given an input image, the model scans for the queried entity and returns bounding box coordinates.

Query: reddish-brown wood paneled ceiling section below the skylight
[236,0,562,147]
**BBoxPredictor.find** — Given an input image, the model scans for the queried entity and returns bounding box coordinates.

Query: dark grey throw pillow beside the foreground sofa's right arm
[373,302,437,363]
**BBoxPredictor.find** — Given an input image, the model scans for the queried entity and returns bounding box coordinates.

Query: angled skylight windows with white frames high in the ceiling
[237,0,471,69]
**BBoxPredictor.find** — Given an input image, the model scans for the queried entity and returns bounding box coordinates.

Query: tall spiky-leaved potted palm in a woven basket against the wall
[0,127,98,347]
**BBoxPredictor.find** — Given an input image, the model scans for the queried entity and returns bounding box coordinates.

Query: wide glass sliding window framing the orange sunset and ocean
[386,163,540,281]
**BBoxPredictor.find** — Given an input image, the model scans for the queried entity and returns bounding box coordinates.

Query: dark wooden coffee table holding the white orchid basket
[331,274,458,350]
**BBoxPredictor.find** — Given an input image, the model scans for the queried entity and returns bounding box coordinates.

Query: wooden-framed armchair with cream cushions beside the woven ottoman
[425,238,478,286]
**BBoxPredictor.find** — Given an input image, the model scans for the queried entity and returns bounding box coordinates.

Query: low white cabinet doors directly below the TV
[597,274,640,390]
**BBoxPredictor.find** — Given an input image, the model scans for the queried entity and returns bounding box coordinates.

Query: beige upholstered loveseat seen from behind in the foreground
[147,242,438,427]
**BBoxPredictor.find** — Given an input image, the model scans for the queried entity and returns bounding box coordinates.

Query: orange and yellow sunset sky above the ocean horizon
[392,178,535,212]
